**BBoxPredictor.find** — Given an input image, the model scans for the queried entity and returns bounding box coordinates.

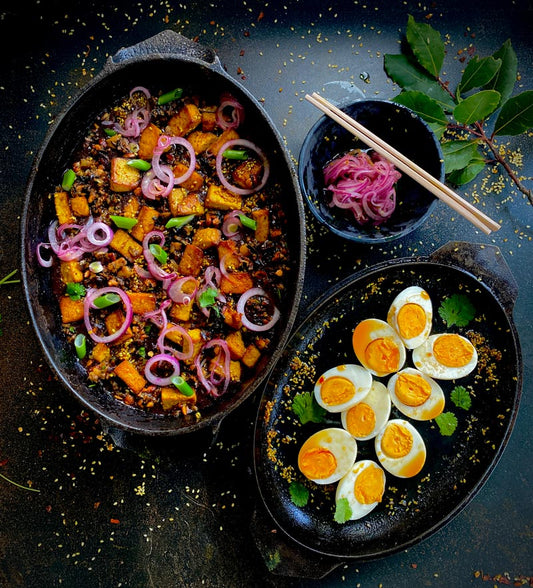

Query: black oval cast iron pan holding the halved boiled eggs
[254,243,522,561]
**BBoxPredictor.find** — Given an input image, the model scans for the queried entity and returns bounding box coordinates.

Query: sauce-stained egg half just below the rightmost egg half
[387,368,445,421]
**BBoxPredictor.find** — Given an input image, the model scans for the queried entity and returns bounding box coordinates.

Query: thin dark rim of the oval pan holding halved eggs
[253,256,523,562]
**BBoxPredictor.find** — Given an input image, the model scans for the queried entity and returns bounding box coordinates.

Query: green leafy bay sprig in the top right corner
[384,15,533,204]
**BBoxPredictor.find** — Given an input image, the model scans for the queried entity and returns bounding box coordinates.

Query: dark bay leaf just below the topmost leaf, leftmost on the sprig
[384,54,455,112]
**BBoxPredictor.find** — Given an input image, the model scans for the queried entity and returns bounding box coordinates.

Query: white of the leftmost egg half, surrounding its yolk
[298,427,357,484]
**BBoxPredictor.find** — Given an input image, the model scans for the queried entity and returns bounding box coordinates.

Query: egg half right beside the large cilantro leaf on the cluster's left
[314,364,372,412]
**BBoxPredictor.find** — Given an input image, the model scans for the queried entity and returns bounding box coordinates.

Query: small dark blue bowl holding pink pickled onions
[298,100,444,244]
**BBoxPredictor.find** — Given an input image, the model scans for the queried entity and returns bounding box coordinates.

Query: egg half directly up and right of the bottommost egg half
[374,419,426,478]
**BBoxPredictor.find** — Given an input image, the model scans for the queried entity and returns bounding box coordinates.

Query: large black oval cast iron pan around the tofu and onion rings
[22,30,305,435]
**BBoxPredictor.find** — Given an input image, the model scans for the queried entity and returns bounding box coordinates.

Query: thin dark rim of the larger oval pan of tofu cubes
[20,31,306,437]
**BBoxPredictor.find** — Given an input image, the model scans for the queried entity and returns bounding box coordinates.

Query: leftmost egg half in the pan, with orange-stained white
[298,427,357,484]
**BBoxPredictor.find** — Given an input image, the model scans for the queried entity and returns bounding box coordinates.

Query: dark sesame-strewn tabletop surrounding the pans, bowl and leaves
[0,0,533,588]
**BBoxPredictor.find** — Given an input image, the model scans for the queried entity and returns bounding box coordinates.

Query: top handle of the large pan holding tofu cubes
[108,29,217,67]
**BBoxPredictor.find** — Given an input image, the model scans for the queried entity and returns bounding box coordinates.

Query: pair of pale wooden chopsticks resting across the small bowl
[305,92,500,235]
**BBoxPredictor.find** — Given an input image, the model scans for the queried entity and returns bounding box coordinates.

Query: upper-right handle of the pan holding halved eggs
[430,241,518,316]
